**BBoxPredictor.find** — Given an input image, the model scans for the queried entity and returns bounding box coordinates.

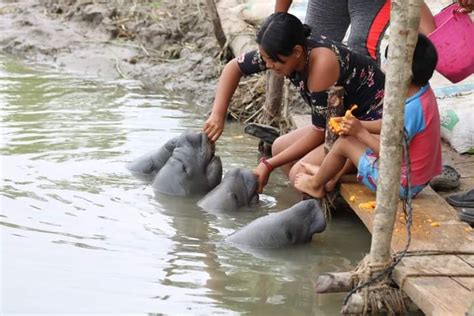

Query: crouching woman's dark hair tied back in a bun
[256,12,311,62]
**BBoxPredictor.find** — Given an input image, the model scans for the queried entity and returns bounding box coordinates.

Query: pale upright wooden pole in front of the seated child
[370,0,422,266]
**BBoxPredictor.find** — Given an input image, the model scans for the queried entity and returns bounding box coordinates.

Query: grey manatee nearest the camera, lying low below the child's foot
[225,199,326,248]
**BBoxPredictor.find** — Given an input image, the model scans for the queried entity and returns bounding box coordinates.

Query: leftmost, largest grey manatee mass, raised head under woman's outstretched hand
[127,131,222,196]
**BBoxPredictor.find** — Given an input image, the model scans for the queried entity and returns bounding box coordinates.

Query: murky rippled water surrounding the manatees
[0,56,369,315]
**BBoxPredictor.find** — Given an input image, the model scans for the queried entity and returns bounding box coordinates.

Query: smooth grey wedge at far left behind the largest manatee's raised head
[127,137,179,180]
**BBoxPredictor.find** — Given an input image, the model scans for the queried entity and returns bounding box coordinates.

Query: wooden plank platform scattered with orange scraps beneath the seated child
[341,183,474,315]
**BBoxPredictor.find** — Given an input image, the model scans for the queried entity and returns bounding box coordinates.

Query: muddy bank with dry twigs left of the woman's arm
[0,0,225,107]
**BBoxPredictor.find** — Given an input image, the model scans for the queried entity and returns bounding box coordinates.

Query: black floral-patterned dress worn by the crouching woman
[237,35,385,129]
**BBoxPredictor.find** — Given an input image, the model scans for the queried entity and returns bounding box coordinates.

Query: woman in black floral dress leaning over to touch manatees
[203,12,385,193]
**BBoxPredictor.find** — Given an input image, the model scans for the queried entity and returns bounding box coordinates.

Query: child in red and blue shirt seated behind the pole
[295,34,442,198]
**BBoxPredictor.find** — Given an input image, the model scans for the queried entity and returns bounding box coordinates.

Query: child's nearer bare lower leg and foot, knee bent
[295,136,366,198]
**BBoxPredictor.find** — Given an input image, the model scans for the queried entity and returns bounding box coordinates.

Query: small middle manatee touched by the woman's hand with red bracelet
[197,168,258,212]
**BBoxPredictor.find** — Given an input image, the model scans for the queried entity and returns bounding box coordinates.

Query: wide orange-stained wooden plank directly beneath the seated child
[341,183,474,252]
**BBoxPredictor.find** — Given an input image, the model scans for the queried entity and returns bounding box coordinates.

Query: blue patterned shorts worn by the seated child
[357,148,426,199]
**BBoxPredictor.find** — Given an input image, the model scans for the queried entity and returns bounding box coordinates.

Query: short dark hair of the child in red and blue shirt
[411,34,438,86]
